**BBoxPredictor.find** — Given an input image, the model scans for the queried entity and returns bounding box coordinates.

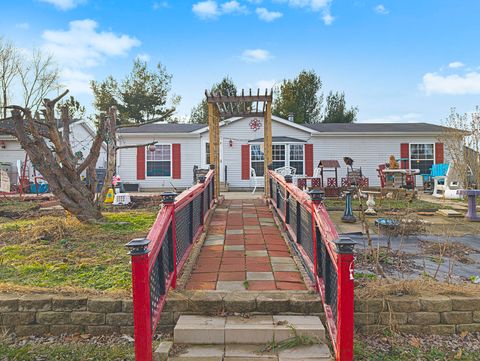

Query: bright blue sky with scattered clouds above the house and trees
[0,0,480,123]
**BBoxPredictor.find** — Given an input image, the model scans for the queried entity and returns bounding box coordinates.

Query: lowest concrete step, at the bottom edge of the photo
[154,341,332,361]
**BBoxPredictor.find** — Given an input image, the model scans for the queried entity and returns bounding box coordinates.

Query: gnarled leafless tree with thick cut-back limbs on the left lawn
[0,90,174,222]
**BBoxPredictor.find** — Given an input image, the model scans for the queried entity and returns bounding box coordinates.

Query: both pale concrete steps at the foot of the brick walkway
[154,315,331,361]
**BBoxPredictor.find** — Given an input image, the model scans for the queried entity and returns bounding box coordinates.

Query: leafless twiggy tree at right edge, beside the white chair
[439,107,480,187]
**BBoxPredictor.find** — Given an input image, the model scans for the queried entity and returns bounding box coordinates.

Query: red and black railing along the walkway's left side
[127,169,215,361]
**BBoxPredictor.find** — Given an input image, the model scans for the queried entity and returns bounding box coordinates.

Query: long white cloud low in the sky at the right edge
[420,72,480,95]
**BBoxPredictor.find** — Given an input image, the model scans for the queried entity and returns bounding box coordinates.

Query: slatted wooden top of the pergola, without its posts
[205,89,273,119]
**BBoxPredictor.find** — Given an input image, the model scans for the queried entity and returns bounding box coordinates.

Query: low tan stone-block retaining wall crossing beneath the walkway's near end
[0,291,480,336]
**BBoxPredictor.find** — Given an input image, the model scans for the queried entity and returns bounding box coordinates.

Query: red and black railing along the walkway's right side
[268,170,354,361]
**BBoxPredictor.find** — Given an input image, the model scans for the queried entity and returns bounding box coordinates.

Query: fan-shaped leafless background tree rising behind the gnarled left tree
[17,50,60,112]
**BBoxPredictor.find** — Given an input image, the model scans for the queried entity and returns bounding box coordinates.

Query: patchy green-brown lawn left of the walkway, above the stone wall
[0,201,156,295]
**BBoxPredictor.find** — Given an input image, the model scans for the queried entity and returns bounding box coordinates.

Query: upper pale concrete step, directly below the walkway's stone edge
[174,315,325,345]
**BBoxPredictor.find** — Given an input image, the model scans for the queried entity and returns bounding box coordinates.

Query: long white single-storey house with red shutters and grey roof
[117,116,448,190]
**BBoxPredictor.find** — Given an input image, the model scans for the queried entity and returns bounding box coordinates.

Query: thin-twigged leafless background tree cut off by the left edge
[0,38,19,118]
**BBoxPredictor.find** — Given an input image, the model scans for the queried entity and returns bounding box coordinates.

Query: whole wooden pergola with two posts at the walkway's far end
[205,89,273,196]
